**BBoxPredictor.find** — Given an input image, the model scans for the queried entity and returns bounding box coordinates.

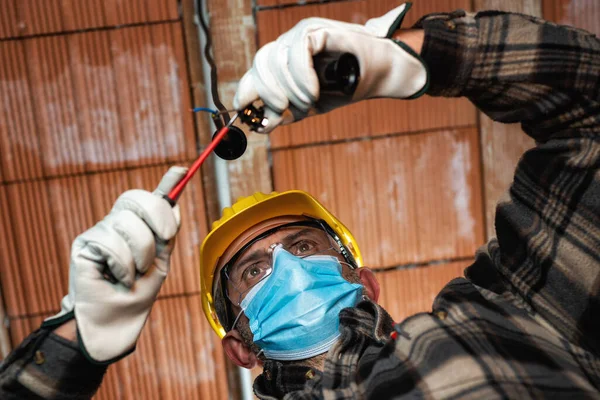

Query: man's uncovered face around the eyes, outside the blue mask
[222,217,361,360]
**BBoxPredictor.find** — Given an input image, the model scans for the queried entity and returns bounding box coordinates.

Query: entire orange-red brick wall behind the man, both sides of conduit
[0,0,600,399]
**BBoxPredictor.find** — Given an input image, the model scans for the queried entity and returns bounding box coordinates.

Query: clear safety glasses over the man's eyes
[221,220,340,305]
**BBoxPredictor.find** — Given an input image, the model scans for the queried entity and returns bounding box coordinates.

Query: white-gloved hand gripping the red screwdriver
[42,167,187,364]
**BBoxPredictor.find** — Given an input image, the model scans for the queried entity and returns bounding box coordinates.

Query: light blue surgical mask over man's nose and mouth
[234,246,363,360]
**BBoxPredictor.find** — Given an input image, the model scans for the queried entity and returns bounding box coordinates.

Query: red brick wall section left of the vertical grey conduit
[0,0,228,399]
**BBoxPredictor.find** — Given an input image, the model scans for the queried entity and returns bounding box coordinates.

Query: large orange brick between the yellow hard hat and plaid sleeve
[272,128,484,268]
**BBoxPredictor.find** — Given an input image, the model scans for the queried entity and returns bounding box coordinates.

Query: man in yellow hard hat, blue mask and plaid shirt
[0,0,600,399]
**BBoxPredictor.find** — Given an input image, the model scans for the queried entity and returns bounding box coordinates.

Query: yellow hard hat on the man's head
[200,190,363,338]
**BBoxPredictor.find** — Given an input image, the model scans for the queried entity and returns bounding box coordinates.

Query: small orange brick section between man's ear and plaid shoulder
[375,260,473,322]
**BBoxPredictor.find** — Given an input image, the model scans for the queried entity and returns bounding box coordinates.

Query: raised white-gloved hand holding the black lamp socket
[233,3,428,133]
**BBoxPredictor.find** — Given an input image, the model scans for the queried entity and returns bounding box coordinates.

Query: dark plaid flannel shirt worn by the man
[0,6,600,400]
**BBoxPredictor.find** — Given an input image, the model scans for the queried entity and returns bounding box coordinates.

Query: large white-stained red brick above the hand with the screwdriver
[8,23,196,181]
